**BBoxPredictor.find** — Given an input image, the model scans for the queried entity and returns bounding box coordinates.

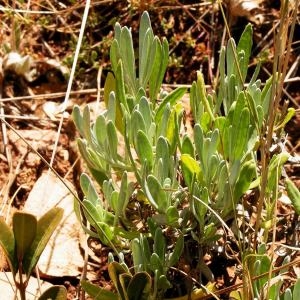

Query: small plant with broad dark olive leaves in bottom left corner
[0,208,67,300]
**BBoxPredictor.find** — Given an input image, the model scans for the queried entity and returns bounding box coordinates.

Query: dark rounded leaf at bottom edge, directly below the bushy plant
[127,272,151,300]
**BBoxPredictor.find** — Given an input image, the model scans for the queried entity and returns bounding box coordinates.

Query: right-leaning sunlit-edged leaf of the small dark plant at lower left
[23,207,64,276]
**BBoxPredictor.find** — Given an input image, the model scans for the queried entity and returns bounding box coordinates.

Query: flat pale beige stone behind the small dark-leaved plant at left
[24,173,84,277]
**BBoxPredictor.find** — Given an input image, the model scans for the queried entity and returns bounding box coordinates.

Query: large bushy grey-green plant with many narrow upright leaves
[73,7,299,299]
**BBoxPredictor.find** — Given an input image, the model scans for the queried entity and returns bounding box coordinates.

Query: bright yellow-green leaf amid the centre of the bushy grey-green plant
[181,154,201,191]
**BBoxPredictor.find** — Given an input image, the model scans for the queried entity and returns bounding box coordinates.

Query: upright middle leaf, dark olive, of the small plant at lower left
[13,212,37,262]
